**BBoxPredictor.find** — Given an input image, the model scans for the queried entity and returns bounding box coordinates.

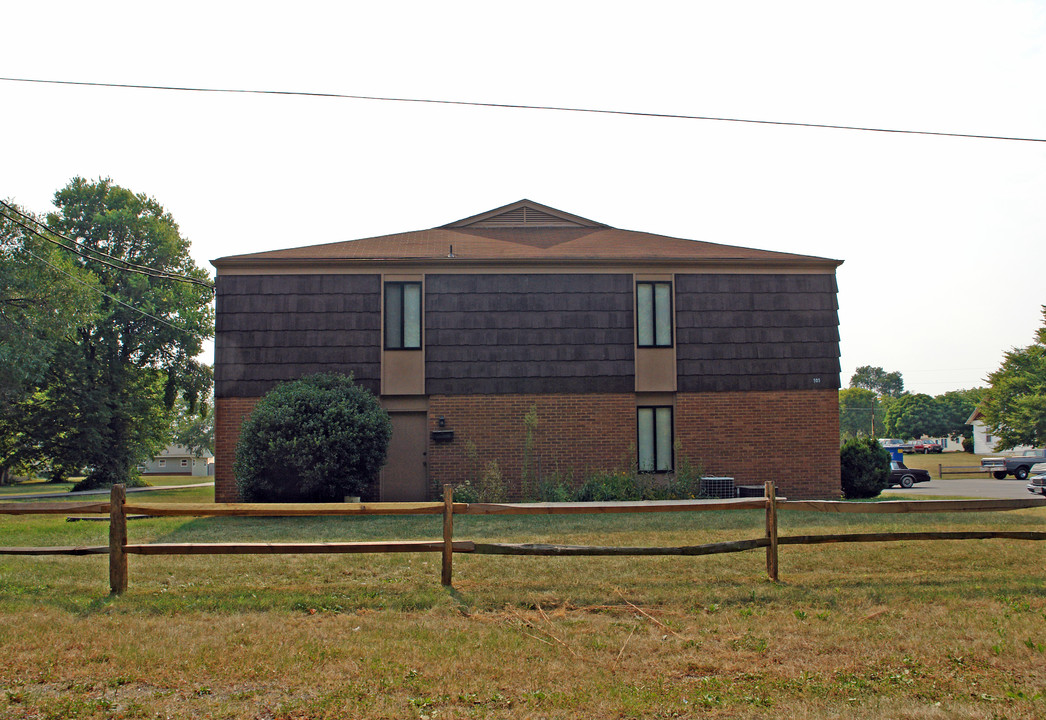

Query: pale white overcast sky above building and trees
[0,0,1046,395]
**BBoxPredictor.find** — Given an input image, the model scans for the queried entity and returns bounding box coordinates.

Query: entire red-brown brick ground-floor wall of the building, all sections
[214,390,841,502]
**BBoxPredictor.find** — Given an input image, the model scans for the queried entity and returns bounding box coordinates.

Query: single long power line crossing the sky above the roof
[0,77,1046,142]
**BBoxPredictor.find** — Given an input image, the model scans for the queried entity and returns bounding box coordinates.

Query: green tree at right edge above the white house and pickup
[979,306,1046,450]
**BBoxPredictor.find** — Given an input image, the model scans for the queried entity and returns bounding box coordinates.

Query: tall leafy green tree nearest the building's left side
[29,178,213,488]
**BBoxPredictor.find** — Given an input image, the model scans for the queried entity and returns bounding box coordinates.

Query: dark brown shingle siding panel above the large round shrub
[214,274,381,398]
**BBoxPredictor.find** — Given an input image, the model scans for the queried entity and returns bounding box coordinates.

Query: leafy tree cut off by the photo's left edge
[0,203,98,485]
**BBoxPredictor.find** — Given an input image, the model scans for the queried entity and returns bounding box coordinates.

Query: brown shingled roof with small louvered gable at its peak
[211,200,842,270]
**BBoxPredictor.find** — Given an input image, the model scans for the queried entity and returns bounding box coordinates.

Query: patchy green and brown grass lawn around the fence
[0,493,1046,719]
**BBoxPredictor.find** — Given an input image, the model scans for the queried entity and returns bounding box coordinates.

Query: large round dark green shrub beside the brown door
[233,374,392,502]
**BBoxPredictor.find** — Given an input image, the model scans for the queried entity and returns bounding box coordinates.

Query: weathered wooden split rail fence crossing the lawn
[0,481,1046,594]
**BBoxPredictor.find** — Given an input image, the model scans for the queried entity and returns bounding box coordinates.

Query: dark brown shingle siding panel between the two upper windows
[425,273,635,395]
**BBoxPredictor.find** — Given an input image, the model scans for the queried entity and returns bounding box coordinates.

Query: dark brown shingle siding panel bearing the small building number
[676,274,839,392]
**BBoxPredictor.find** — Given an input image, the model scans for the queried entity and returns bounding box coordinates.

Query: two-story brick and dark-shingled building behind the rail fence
[212,200,841,502]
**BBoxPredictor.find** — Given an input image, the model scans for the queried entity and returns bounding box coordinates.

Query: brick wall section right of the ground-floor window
[676,390,842,499]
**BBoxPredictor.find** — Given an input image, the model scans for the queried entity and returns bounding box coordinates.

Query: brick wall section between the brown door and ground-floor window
[428,393,636,499]
